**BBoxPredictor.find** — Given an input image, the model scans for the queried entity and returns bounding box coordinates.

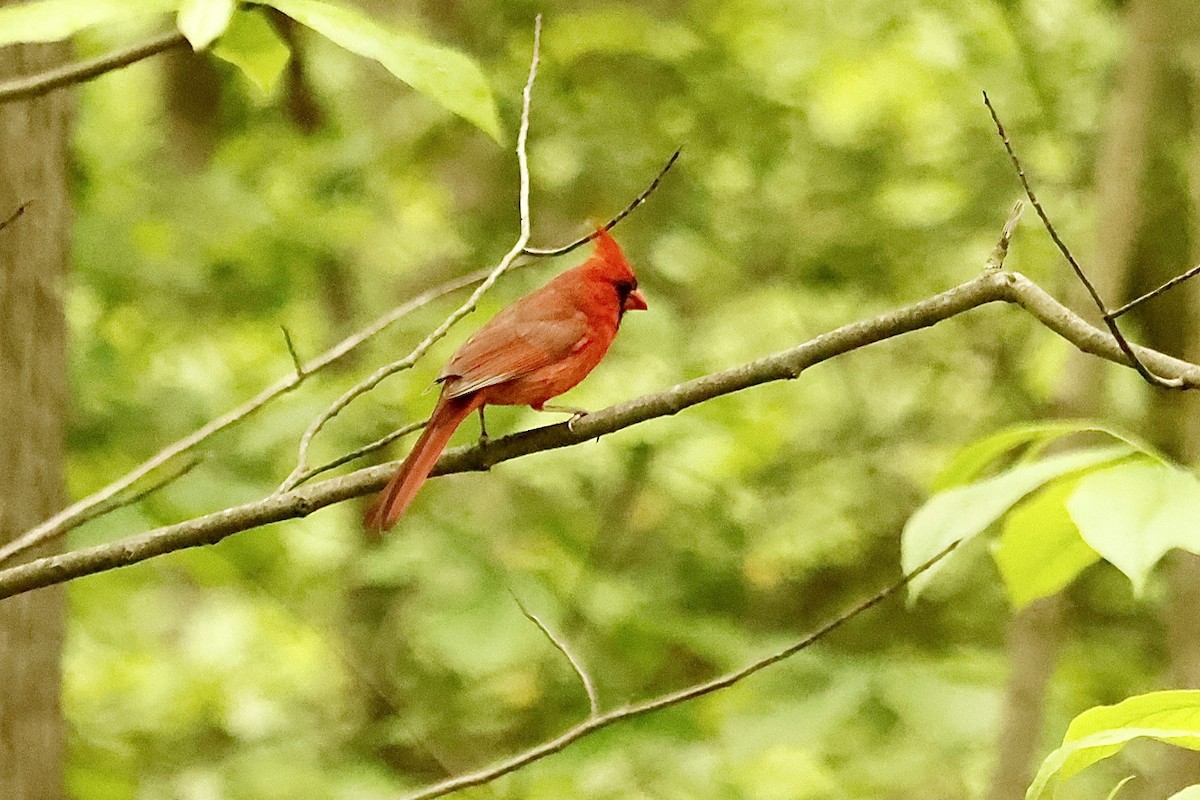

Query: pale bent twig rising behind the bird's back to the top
[277,14,541,493]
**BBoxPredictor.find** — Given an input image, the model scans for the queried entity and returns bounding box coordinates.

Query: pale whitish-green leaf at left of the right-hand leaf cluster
[900,444,1133,599]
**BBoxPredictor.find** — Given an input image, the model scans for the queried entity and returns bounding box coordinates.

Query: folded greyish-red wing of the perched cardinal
[438,292,588,397]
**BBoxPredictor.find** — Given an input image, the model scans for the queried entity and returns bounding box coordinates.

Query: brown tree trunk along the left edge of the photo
[0,32,70,800]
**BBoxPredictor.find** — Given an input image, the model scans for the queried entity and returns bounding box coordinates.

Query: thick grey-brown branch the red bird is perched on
[0,271,1200,599]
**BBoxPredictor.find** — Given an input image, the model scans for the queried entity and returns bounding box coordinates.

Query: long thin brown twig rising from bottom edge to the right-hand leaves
[403,541,958,800]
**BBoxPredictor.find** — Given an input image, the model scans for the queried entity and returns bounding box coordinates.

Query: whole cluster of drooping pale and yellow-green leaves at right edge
[901,422,1200,607]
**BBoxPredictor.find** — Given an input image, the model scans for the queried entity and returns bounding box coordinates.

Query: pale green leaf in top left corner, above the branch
[0,0,179,46]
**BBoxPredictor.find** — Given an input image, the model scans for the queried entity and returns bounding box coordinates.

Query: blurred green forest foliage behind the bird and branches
[49,0,1190,800]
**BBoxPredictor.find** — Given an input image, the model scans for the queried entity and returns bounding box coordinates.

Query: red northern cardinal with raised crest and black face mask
[362,229,646,533]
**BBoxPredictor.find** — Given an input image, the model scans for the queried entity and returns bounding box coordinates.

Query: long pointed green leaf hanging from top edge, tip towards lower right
[253,0,500,142]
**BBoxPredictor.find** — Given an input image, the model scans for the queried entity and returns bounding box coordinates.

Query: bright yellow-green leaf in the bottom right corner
[1025,690,1200,800]
